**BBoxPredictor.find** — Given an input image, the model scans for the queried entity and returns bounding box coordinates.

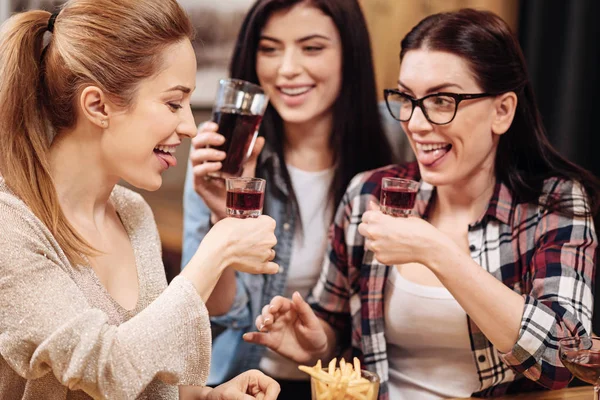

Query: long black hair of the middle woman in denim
[229,0,392,216]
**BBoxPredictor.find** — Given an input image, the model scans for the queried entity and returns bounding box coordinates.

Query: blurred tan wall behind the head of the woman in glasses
[359,0,519,97]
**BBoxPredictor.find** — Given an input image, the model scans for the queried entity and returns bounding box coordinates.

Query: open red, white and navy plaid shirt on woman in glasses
[309,163,598,400]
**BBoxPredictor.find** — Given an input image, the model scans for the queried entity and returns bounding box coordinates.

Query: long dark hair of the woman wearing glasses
[400,9,600,226]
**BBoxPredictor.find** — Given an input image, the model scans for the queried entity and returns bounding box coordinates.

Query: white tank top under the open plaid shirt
[384,267,479,400]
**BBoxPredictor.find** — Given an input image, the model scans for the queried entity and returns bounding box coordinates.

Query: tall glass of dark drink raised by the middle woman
[209,79,269,178]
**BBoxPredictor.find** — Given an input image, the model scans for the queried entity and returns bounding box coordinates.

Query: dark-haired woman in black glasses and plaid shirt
[245,9,600,400]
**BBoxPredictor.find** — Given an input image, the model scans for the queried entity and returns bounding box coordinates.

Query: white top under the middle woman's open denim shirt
[260,165,334,380]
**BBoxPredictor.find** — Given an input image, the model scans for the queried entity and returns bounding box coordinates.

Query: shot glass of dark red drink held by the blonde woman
[225,178,266,218]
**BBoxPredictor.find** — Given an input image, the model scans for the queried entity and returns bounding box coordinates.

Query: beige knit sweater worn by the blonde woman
[0,177,211,400]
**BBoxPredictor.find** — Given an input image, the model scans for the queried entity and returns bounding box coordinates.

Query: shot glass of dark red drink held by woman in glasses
[380,178,419,217]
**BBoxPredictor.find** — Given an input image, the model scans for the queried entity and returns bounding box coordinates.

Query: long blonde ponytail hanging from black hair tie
[0,11,95,264]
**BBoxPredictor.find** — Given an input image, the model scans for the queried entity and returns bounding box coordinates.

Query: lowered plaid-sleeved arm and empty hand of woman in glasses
[243,175,370,364]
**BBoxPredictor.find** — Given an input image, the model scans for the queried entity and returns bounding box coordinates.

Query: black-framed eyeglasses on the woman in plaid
[383,89,496,125]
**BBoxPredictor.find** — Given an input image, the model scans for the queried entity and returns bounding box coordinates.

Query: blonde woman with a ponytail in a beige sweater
[0,0,279,400]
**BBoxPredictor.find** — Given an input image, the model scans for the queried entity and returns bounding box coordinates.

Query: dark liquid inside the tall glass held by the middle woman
[213,109,262,176]
